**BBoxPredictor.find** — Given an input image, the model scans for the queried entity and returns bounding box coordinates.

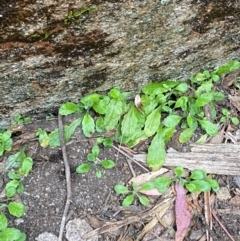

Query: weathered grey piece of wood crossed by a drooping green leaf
[133,144,240,175]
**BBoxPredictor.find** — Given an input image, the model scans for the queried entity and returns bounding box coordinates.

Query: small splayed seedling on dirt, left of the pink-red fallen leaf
[114,183,149,207]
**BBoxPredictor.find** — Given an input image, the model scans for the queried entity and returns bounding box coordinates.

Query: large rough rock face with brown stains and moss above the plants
[0,0,240,129]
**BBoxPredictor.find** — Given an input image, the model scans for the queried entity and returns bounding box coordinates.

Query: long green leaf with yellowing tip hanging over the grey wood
[147,128,166,171]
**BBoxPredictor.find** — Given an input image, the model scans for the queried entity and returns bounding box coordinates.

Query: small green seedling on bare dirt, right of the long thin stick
[76,137,115,178]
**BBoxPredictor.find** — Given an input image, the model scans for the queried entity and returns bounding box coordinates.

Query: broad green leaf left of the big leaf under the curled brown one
[104,99,125,131]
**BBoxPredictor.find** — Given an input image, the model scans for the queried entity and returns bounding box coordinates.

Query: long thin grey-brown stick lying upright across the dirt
[58,114,72,241]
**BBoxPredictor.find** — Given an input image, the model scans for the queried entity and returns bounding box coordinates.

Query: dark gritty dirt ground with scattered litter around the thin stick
[1,112,240,241]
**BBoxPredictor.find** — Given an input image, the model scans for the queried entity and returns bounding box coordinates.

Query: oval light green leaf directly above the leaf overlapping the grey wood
[144,108,161,137]
